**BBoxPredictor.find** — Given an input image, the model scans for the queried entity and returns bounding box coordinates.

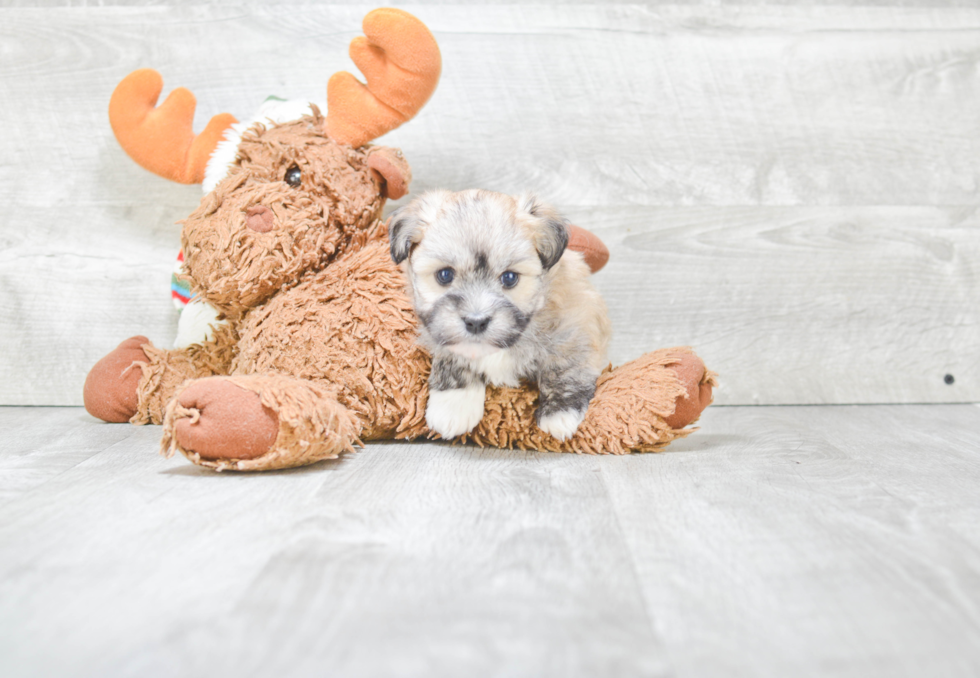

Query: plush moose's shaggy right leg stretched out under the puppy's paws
[470,348,715,454]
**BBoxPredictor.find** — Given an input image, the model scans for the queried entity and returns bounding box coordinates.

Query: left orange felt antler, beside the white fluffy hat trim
[109,68,238,184]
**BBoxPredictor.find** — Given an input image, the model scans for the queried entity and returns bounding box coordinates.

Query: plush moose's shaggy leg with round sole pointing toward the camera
[161,374,363,471]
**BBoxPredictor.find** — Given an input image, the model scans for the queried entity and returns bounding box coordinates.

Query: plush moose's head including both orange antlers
[109,9,441,318]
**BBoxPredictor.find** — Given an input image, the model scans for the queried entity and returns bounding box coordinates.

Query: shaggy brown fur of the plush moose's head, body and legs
[87,112,713,470]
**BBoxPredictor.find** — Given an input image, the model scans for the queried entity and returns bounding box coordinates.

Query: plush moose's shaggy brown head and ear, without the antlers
[181,109,411,318]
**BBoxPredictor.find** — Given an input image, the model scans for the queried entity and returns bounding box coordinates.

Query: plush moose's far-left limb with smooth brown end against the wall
[83,327,237,424]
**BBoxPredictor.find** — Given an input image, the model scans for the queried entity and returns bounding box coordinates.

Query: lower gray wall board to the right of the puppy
[580,207,980,404]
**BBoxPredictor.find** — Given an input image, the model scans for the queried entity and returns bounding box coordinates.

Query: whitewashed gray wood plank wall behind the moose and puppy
[0,0,980,405]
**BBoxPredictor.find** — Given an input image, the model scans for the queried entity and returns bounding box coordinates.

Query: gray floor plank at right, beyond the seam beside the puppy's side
[603,405,980,676]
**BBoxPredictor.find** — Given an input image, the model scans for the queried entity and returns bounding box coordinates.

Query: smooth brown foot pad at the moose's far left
[82,336,150,424]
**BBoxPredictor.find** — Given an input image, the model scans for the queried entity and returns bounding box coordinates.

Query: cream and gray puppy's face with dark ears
[388,190,568,359]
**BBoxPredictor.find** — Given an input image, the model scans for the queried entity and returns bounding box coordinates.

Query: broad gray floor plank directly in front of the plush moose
[0,410,667,676]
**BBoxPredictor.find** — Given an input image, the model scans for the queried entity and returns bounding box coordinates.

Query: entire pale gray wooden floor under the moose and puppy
[0,405,980,678]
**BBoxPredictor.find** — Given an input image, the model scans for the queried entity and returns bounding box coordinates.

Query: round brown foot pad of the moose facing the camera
[174,377,279,459]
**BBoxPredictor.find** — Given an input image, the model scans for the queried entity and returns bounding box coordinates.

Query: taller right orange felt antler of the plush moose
[326,8,442,147]
